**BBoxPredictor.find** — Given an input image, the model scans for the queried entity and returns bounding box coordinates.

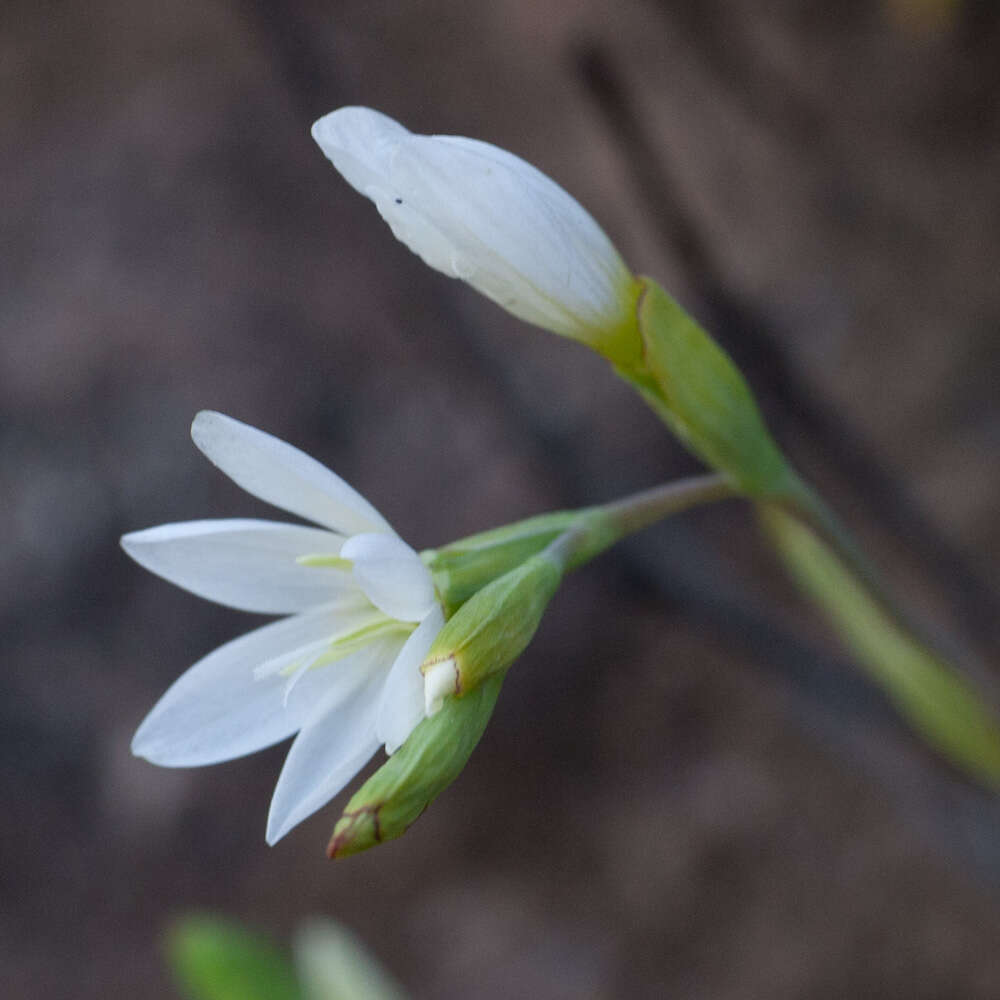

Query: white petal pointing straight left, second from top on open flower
[122,519,356,614]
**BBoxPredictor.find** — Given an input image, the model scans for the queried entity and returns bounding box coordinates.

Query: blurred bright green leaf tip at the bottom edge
[166,916,302,1000]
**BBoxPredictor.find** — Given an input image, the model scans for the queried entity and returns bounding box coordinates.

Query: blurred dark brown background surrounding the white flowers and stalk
[0,0,1000,1000]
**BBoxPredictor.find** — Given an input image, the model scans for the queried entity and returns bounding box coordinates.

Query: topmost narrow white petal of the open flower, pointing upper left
[191,410,392,535]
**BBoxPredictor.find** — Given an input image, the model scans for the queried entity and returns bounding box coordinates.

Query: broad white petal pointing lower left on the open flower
[132,605,370,767]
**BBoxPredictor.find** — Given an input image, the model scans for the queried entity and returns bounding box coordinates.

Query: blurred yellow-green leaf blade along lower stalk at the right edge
[761,505,1000,789]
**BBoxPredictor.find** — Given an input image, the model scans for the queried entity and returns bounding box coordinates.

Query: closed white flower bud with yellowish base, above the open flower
[312,107,635,343]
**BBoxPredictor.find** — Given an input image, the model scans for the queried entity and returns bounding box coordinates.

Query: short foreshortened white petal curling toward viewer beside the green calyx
[340,534,435,622]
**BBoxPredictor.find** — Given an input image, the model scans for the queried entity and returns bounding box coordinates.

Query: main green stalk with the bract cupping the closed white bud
[616,278,1000,788]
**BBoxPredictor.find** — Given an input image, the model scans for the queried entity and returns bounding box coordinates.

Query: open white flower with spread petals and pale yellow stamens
[122,412,444,844]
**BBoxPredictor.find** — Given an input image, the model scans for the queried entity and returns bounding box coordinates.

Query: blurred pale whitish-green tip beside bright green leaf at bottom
[295,918,406,1000]
